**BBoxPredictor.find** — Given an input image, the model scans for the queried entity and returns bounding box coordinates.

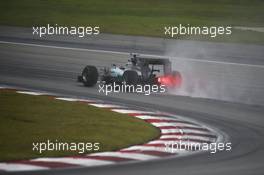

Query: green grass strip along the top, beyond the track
[0,0,264,44]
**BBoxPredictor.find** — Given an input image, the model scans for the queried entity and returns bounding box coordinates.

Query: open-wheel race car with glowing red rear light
[78,54,182,88]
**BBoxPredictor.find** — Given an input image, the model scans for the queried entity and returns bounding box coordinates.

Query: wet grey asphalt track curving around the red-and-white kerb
[0,27,264,175]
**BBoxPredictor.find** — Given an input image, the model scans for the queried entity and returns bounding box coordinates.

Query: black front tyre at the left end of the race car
[82,65,99,87]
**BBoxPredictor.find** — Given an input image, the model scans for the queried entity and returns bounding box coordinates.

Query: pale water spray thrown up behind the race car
[165,41,250,103]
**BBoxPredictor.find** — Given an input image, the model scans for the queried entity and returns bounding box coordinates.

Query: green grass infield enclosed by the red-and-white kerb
[0,90,159,161]
